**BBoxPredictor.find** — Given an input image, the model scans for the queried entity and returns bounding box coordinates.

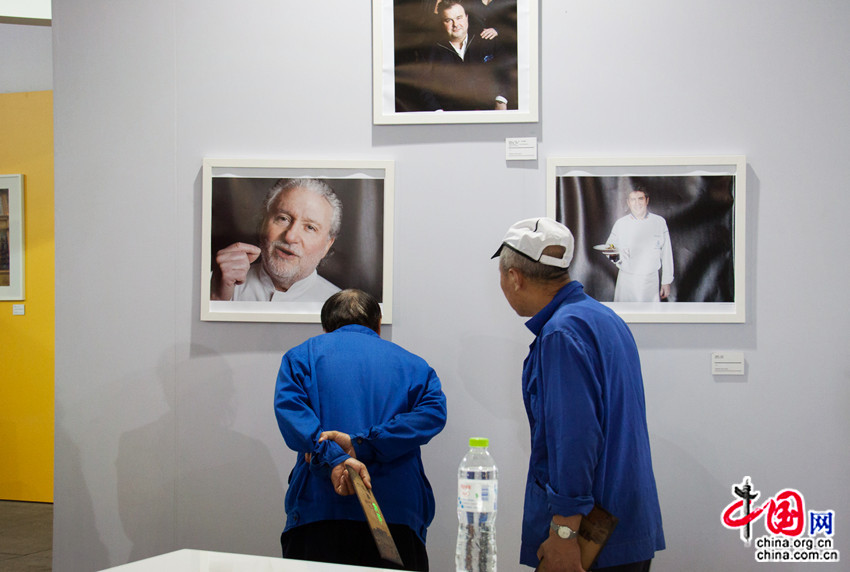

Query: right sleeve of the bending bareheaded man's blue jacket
[351,368,446,463]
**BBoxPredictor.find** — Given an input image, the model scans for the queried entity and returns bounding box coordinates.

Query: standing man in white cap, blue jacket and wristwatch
[494,218,664,572]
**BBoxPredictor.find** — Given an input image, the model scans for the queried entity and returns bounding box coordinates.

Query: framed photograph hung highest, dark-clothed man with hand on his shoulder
[372,0,539,125]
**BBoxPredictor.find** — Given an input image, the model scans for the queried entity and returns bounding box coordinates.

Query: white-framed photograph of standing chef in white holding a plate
[547,156,747,323]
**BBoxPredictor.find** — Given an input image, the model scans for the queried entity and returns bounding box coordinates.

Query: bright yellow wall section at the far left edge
[0,91,55,502]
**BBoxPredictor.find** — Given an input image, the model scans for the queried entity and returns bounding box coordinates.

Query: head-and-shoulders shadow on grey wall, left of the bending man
[116,346,283,561]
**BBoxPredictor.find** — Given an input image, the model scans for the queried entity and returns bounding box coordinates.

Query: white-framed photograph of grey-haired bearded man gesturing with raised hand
[201,159,394,324]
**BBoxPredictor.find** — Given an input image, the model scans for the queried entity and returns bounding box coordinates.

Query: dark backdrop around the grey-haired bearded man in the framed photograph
[210,177,384,302]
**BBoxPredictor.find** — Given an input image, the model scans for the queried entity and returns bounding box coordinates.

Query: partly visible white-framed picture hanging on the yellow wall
[0,175,24,300]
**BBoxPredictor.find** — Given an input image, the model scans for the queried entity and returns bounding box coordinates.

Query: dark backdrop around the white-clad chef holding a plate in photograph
[555,175,735,302]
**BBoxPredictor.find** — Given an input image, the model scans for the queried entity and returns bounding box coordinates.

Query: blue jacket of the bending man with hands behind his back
[275,325,446,543]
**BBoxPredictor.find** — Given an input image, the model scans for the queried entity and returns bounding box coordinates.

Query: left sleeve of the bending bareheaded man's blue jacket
[274,348,348,472]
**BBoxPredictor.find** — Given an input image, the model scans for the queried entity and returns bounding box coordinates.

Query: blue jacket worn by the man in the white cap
[520,281,664,567]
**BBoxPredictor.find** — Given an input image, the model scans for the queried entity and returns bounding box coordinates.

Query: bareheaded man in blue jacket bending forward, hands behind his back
[275,290,446,570]
